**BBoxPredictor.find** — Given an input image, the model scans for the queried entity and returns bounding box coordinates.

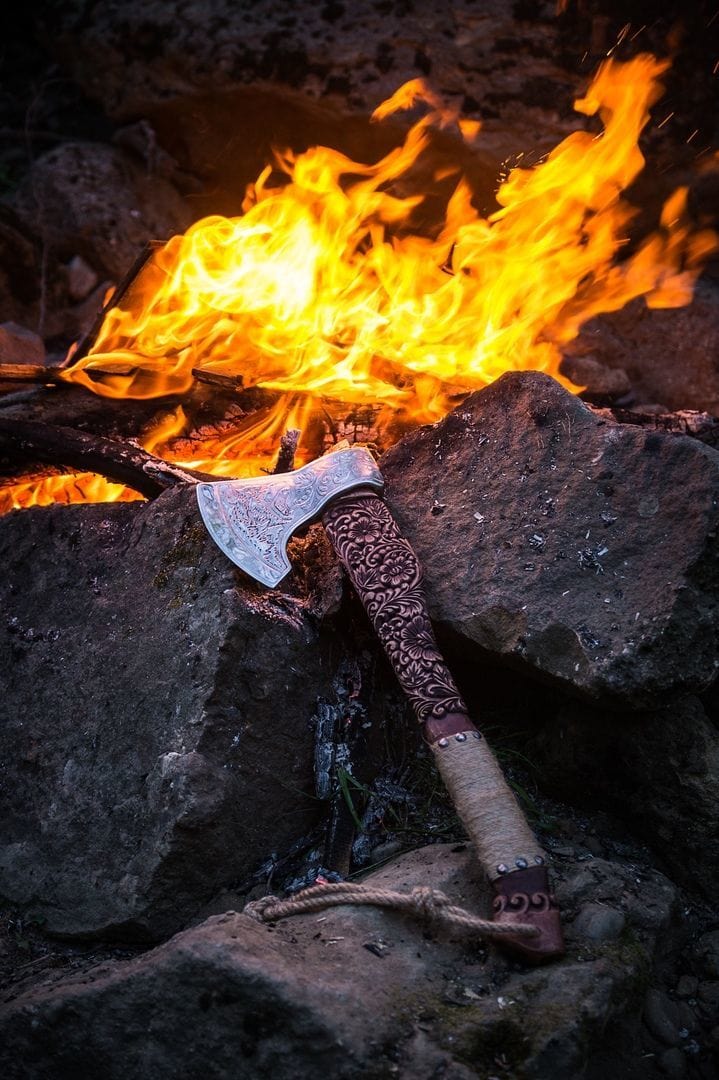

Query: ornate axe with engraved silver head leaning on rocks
[196,446,564,963]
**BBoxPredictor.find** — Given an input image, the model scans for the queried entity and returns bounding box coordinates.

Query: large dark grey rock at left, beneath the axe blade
[0,489,360,939]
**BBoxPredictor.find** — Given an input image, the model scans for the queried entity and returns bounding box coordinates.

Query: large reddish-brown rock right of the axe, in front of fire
[381,373,719,708]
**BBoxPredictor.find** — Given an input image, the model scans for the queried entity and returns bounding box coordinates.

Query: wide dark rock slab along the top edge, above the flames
[40,0,582,157]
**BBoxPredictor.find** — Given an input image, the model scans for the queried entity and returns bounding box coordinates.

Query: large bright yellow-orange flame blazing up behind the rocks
[7,54,717,511]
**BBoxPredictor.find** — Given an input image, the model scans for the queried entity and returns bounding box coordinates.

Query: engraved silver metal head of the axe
[198,446,384,589]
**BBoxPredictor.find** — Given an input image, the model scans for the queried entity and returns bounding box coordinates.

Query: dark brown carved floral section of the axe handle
[322,490,472,727]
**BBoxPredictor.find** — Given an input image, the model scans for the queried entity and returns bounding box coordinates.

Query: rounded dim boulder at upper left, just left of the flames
[13,143,191,282]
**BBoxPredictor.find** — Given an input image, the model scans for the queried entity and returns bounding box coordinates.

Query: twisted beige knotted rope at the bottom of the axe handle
[243,881,540,937]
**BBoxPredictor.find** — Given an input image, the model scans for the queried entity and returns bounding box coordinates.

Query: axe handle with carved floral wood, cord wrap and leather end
[323,488,562,962]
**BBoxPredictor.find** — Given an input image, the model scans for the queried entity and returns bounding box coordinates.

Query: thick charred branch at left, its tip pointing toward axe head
[0,420,217,499]
